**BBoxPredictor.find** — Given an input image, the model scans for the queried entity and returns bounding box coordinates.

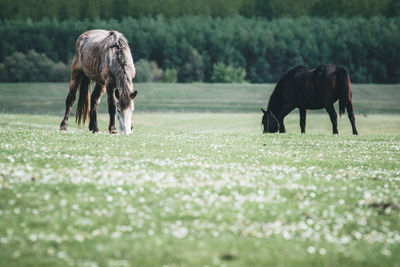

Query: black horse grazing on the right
[261,65,358,134]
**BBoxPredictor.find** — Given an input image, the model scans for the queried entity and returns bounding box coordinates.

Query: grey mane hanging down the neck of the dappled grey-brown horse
[109,31,135,109]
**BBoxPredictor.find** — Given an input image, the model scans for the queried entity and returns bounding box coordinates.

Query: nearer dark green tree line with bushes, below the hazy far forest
[0,16,400,83]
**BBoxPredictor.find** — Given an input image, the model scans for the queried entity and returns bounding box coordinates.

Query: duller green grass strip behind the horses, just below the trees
[0,83,400,115]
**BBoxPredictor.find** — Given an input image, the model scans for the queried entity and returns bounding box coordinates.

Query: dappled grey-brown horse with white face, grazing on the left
[60,30,137,134]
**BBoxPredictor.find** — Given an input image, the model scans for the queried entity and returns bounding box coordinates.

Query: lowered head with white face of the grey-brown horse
[115,89,137,135]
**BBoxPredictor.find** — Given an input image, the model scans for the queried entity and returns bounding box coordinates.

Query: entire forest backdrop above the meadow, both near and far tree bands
[0,0,400,83]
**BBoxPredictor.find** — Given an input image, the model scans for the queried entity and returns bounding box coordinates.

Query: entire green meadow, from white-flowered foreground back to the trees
[0,84,400,266]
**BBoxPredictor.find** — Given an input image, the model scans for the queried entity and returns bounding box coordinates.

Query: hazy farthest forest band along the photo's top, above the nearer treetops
[0,0,400,21]
